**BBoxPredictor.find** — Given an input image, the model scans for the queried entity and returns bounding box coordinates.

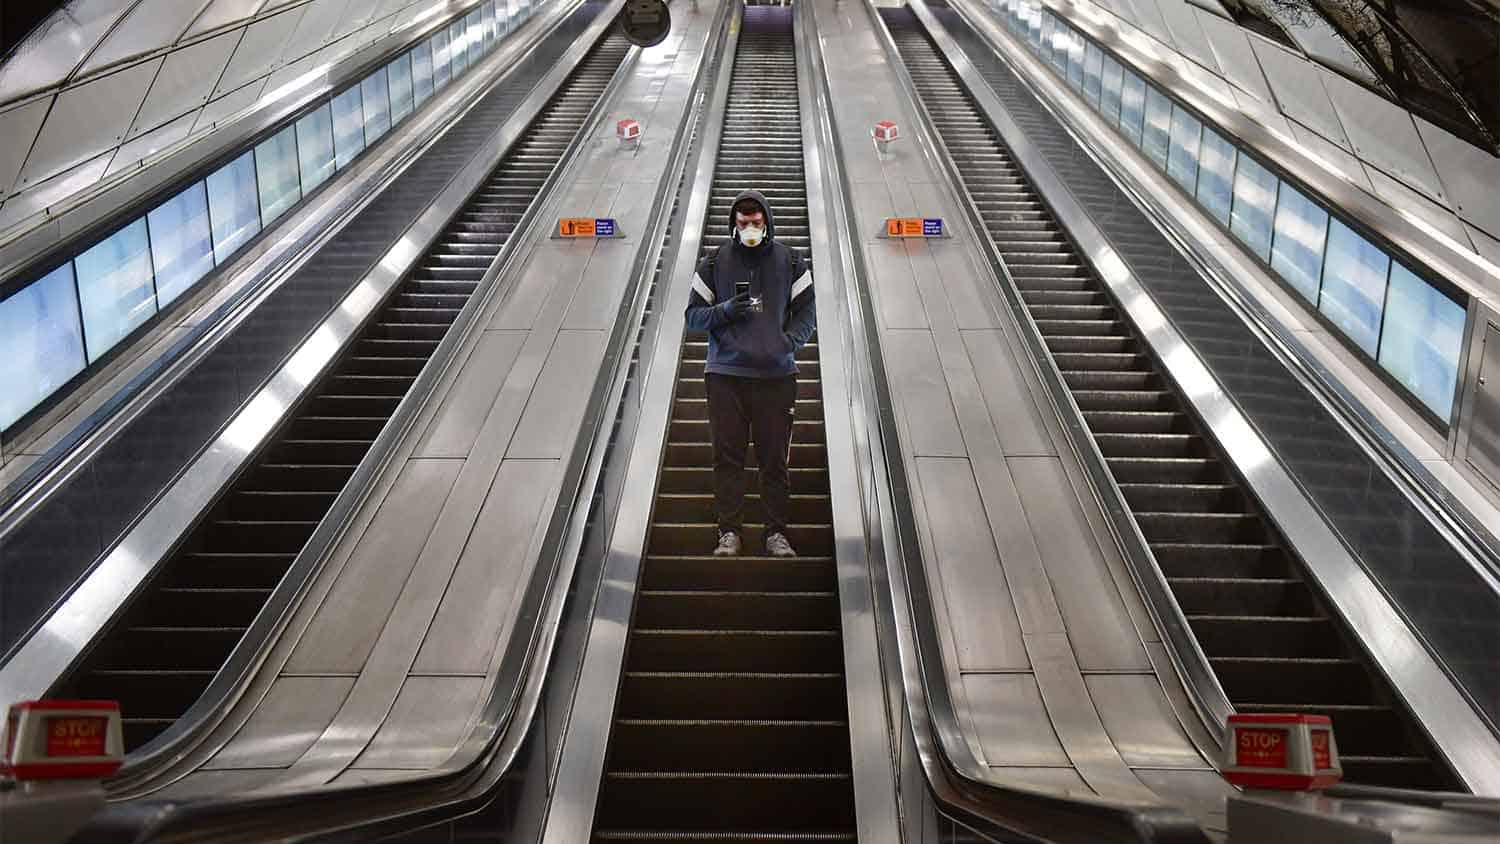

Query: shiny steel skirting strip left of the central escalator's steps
[542,3,744,844]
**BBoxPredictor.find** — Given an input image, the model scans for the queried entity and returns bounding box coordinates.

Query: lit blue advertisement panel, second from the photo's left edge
[74,217,156,363]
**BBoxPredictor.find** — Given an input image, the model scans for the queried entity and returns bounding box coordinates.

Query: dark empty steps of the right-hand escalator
[881,7,1455,789]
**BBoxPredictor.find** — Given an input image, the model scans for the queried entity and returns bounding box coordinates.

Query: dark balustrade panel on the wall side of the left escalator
[0,3,599,668]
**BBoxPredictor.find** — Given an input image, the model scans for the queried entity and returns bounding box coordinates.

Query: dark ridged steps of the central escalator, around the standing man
[594,6,855,841]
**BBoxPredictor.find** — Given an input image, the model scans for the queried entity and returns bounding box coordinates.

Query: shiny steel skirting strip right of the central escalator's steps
[792,3,902,844]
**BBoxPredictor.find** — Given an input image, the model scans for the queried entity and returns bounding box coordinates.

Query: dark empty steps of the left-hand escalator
[57,34,630,751]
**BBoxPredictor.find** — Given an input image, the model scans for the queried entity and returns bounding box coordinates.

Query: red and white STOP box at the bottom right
[1223,714,1344,792]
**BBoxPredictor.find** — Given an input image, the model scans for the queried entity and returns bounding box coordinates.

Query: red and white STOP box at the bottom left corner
[0,700,125,781]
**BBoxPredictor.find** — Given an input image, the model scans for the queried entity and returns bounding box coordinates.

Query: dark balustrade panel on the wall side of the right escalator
[933,0,1500,734]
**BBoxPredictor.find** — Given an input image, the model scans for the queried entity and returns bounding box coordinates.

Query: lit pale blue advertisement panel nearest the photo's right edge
[1380,264,1464,421]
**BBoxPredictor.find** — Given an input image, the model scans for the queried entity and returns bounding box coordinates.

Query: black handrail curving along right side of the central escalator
[807,3,1208,844]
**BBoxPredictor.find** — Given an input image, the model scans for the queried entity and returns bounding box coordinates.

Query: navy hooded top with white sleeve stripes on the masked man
[687,190,818,378]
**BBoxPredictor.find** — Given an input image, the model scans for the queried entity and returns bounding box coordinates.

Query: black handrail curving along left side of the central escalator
[74,0,734,843]
